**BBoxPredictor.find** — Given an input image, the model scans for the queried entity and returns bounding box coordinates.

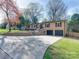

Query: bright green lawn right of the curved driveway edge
[44,38,79,59]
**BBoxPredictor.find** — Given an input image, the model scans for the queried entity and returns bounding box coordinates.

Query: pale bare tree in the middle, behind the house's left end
[24,3,43,24]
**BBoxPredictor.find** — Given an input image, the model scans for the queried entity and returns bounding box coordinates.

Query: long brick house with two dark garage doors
[26,20,67,36]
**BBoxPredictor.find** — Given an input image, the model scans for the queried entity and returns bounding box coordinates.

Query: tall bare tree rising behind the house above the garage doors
[48,0,67,20]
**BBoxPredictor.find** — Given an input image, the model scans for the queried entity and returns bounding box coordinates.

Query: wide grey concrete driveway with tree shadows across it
[0,36,62,59]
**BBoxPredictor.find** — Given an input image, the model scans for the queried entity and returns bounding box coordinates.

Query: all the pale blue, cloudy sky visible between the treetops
[0,0,79,23]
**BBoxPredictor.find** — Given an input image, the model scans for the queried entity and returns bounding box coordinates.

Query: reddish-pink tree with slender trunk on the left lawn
[0,0,19,31]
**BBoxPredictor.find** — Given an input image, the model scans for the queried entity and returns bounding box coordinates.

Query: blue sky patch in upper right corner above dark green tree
[64,0,79,16]
